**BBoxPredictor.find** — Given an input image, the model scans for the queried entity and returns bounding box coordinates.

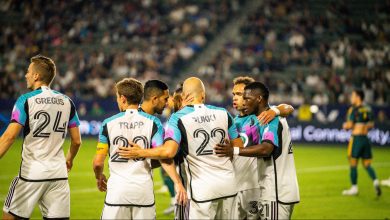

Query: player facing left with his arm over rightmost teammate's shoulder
[232,77,294,219]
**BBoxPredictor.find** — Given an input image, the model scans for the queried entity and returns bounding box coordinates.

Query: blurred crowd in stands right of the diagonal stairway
[199,0,390,105]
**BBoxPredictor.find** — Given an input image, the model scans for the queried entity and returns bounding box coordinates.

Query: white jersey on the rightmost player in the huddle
[258,117,300,204]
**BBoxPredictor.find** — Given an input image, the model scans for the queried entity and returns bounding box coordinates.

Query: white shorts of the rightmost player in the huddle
[260,200,294,220]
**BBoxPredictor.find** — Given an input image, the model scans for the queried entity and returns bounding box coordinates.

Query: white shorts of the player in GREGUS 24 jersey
[3,177,70,218]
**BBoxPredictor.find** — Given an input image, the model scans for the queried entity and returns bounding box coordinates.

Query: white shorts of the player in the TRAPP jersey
[101,204,156,219]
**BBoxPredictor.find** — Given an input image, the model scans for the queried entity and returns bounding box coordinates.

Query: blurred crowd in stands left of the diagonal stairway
[0,0,243,99]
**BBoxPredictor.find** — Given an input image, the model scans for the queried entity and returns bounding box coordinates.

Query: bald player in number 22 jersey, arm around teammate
[119,77,243,219]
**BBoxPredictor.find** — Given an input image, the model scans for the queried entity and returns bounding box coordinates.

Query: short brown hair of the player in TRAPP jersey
[115,78,144,105]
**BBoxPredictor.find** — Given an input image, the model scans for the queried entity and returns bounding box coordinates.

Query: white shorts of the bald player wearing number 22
[189,196,237,219]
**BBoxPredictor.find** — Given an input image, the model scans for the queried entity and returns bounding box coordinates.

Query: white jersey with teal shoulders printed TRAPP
[99,109,164,207]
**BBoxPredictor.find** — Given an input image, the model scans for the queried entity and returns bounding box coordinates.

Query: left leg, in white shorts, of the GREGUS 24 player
[3,177,46,219]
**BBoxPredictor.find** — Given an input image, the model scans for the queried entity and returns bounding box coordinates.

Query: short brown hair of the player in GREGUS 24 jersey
[30,55,56,85]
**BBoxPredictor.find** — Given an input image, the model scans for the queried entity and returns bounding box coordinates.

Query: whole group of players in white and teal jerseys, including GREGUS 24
[0,55,300,219]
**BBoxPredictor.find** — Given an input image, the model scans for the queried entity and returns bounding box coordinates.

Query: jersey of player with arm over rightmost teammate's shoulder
[233,115,260,191]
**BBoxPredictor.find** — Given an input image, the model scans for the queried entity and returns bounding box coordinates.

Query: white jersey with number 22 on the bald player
[164,104,239,202]
